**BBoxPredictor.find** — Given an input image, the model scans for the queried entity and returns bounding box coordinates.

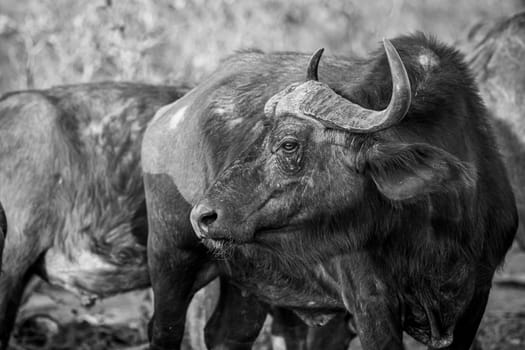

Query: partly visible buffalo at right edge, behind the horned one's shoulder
[467,12,525,249]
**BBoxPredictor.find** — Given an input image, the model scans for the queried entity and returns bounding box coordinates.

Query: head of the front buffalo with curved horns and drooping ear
[191,40,472,245]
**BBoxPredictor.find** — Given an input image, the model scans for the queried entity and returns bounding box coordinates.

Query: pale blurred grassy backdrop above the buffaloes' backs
[0,0,525,93]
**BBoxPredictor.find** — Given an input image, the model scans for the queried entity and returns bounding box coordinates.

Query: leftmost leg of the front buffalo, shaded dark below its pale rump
[144,174,206,349]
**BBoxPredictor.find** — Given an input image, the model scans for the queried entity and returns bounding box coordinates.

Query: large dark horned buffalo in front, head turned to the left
[142,34,517,350]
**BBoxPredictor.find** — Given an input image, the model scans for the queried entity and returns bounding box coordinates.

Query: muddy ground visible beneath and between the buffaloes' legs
[10,249,525,350]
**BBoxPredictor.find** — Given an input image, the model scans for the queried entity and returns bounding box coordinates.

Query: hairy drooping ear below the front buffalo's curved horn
[365,143,476,201]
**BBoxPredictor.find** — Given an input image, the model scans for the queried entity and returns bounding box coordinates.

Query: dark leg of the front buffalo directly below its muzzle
[204,278,268,350]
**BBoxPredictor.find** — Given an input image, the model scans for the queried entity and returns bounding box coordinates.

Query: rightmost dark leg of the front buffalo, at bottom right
[429,290,490,350]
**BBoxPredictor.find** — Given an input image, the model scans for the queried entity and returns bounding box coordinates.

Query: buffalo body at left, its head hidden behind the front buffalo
[0,83,189,349]
